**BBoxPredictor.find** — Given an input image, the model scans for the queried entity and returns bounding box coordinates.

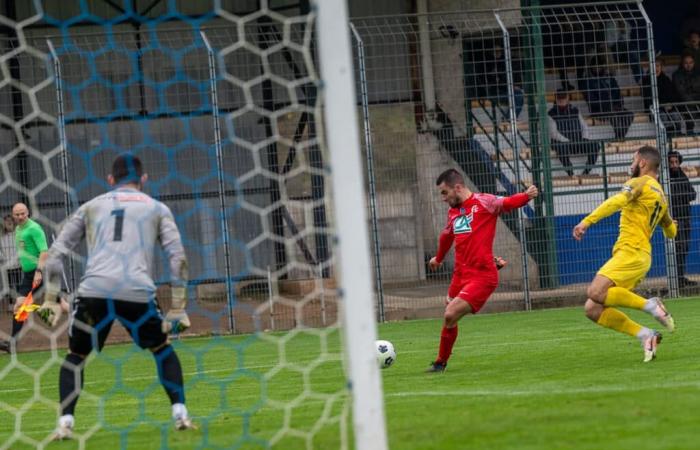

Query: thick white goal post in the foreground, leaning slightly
[317,0,388,450]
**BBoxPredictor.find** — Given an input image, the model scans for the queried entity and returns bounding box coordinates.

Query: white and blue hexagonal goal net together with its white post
[0,0,386,449]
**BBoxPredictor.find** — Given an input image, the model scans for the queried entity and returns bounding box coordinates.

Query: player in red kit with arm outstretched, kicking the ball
[428,169,538,372]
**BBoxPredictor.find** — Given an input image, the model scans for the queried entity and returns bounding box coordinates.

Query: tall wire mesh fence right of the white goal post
[351,2,700,318]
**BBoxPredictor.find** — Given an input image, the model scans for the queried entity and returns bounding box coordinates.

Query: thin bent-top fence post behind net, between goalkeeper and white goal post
[199,31,236,333]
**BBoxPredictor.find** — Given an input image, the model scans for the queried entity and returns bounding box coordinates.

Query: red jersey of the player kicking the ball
[435,193,530,273]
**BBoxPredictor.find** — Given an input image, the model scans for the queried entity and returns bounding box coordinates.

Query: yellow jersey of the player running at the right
[583,175,676,254]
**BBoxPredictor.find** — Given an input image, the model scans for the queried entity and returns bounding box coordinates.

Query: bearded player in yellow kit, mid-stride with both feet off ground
[573,146,676,362]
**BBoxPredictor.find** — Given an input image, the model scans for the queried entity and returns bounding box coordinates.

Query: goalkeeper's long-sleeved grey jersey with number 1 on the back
[46,187,187,302]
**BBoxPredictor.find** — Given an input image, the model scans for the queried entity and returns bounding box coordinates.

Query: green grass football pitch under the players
[0,299,700,450]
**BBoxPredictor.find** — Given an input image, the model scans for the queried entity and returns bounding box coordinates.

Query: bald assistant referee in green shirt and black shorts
[0,203,49,352]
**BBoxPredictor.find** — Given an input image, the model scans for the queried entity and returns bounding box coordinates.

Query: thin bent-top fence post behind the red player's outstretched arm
[494,11,532,311]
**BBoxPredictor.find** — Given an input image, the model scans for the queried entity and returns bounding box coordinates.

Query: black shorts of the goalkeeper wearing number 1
[68,297,168,355]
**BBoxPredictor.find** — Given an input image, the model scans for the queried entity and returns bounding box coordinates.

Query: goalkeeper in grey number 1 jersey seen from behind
[37,153,194,440]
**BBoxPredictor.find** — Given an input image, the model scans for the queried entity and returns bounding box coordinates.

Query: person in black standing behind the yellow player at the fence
[668,151,698,287]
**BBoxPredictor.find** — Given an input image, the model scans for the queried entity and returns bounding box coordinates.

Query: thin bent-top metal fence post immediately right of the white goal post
[350,23,386,322]
